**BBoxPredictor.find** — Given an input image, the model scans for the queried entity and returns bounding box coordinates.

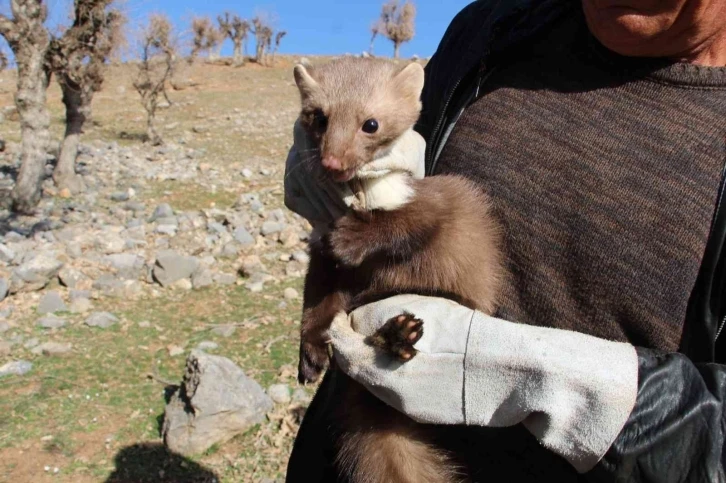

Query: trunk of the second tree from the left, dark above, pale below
[53,78,91,194]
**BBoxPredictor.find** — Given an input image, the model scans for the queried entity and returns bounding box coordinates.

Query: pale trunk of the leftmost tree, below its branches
[13,43,50,213]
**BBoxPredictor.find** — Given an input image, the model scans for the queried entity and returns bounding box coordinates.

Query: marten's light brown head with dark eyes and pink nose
[295,58,424,182]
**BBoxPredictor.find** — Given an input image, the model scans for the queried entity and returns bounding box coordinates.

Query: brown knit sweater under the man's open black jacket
[437,15,726,351]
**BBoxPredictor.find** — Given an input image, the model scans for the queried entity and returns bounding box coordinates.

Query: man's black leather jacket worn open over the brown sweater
[288,0,726,482]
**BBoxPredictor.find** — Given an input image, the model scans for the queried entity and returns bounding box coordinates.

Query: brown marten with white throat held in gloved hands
[294,58,503,483]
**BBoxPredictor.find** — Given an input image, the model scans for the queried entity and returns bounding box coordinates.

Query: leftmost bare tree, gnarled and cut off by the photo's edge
[0,0,50,213]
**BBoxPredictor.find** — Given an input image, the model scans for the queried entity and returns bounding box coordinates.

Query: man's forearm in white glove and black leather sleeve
[331,296,726,476]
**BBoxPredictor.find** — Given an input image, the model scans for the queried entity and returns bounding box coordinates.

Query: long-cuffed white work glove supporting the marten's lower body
[330,295,638,473]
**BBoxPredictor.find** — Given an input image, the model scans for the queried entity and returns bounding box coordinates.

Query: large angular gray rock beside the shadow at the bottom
[162,350,273,456]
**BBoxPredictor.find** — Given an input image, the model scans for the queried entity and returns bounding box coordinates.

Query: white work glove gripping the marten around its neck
[285,121,426,227]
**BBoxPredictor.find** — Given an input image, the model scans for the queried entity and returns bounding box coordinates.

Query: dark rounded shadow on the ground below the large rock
[106,444,219,483]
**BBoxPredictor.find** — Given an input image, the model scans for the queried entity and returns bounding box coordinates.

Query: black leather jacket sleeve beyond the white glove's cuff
[587,349,726,483]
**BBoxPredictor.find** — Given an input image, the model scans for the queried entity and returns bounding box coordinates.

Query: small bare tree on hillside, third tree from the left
[134,14,176,145]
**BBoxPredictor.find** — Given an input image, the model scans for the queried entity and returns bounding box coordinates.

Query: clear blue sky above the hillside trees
[37,0,470,57]
